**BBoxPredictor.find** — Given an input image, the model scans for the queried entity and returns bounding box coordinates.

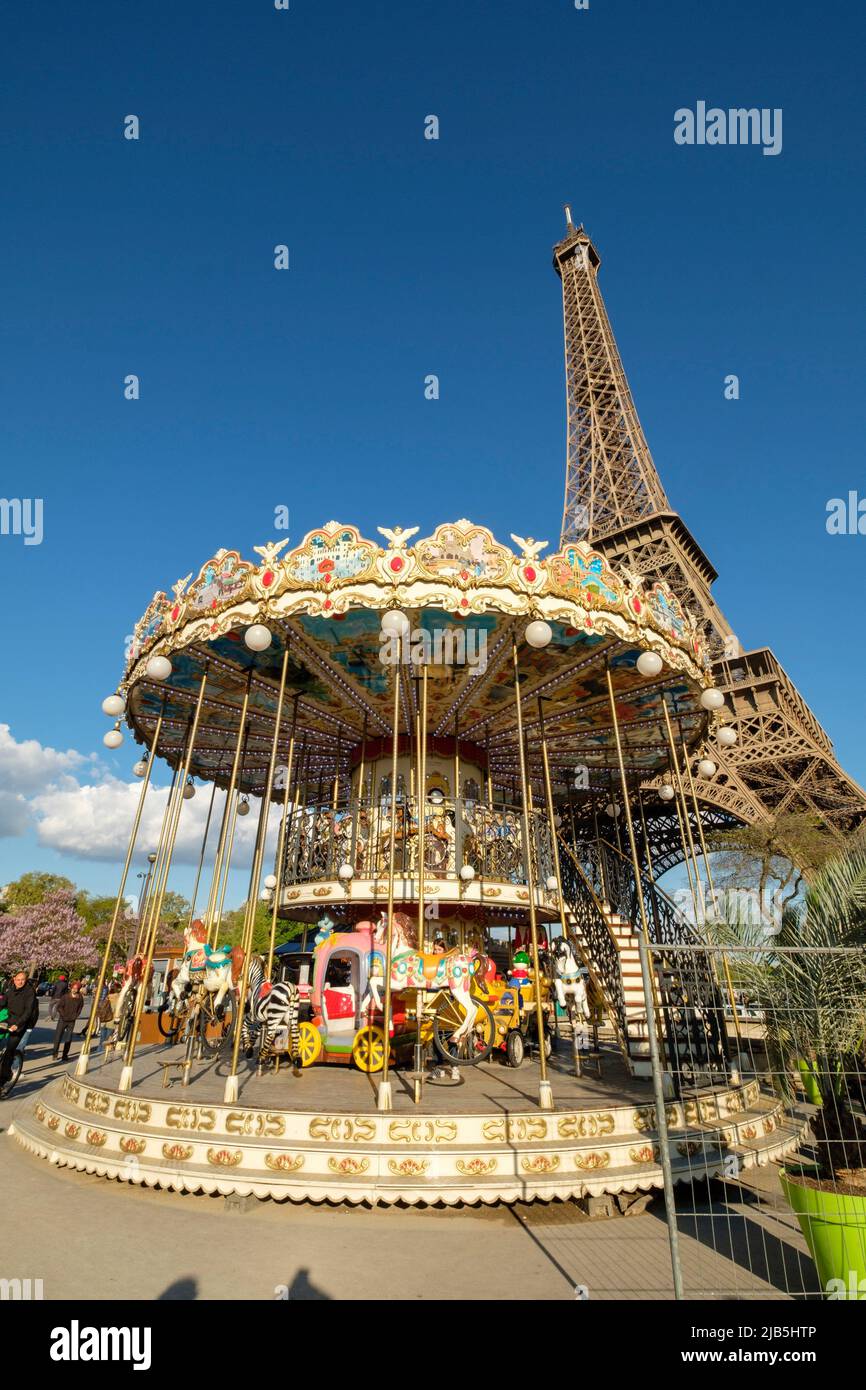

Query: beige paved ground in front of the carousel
[0,1029,815,1301]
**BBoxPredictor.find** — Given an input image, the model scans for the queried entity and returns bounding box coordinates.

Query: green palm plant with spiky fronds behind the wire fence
[712,842,866,1179]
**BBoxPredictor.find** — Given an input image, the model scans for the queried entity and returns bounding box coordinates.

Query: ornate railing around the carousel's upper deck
[282,795,555,888]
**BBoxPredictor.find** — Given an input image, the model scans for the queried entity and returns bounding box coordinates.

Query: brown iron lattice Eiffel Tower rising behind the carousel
[553,209,866,872]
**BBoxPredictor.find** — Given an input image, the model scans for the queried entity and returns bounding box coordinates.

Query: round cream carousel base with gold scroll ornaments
[13,1047,803,1205]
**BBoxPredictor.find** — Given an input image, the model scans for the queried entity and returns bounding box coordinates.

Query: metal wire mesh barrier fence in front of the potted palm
[641,942,866,1301]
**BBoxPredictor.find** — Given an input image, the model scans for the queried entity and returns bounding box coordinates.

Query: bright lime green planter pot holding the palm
[778,1170,866,1298]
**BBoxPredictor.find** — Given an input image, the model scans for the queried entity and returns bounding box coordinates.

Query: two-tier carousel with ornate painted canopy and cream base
[8,520,798,1209]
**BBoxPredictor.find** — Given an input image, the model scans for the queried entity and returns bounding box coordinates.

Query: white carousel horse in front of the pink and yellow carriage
[359,912,485,1043]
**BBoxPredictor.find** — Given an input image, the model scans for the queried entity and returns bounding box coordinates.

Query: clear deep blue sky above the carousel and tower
[0,0,866,901]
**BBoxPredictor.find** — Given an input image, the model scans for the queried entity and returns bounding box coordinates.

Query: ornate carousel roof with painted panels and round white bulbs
[121,520,710,791]
